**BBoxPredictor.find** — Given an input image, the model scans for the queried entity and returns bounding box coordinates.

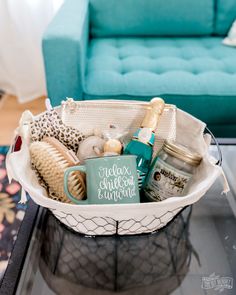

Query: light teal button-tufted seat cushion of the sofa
[84,37,236,96]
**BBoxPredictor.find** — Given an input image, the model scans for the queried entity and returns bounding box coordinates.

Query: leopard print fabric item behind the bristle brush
[30,110,85,153]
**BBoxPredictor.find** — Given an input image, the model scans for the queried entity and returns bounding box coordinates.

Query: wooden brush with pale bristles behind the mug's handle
[30,137,86,203]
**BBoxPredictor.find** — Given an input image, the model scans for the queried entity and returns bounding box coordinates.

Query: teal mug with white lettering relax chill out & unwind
[64,155,140,204]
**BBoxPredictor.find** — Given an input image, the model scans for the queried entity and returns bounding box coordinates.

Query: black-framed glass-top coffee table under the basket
[0,146,236,295]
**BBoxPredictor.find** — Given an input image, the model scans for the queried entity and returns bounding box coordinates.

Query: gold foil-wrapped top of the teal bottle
[141,97,165,131]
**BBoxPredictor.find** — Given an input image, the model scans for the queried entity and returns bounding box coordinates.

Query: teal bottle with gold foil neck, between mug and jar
[124,98,165,189]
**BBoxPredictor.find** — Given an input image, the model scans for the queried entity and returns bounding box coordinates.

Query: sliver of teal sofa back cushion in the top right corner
[215,0,236,35]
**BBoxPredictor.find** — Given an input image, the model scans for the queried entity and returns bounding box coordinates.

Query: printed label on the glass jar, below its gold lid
[145,158,192,201]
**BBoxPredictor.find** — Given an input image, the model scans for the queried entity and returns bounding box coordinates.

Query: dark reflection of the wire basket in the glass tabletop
[41,206,192,294]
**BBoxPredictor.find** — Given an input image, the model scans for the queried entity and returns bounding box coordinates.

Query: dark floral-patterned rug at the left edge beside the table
[0,146,26,281]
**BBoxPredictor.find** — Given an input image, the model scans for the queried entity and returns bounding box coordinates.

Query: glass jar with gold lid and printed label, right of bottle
[144,141,202,201]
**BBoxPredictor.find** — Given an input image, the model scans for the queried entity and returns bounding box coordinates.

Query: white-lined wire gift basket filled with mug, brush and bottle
[6,99,228,235]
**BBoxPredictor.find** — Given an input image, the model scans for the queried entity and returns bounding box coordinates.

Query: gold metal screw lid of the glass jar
[163,140,202,166]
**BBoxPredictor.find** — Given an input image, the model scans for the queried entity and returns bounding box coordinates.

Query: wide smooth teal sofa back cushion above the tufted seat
[90,0,215,37]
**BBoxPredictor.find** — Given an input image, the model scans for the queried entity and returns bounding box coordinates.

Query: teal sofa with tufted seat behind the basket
[43,0,236,137]
